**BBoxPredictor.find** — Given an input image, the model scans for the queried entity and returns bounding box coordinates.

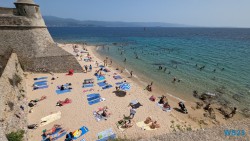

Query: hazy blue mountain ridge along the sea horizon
[43,16,190,27]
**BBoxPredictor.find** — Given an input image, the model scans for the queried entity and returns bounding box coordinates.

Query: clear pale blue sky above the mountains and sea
[0,0,250,27]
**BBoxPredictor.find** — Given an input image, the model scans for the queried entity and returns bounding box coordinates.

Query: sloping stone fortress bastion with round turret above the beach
[0,0,82,72]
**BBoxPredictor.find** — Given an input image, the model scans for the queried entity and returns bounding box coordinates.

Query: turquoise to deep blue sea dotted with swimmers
[49,27,250,113]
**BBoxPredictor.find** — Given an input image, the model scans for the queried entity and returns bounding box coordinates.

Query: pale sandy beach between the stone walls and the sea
[26,44,240,141]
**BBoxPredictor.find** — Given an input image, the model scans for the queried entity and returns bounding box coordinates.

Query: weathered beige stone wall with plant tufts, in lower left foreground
[0,53,28,141]
